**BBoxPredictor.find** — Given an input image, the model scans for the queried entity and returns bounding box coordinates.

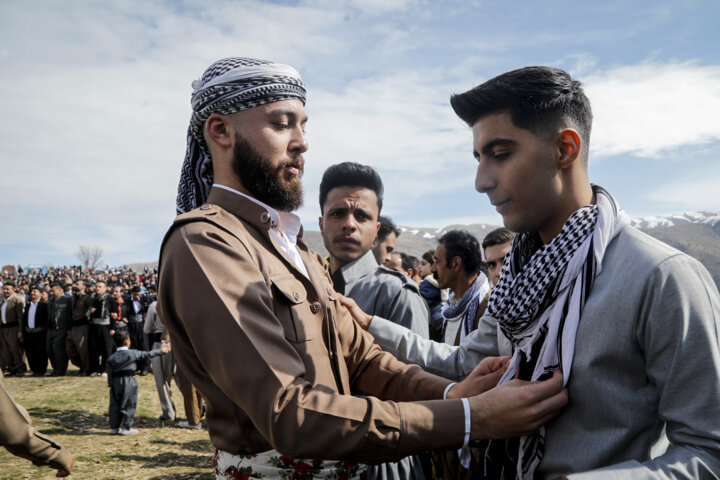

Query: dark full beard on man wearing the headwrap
[232,134,303,212]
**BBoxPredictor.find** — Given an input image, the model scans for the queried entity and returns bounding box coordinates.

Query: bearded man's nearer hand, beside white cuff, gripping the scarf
[470,371,568,440]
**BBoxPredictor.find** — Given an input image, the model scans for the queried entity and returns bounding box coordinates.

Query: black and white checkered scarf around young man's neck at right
[486,185,629,479]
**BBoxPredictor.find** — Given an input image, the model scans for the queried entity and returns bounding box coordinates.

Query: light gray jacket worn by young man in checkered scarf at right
[370,227,720,479]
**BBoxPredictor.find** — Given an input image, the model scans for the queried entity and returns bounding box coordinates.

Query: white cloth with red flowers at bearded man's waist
[213,450,367,480]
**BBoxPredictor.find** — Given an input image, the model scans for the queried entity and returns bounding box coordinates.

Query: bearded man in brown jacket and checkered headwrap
[158,58,565,479]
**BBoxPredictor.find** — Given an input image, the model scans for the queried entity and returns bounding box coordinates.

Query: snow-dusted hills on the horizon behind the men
[304,212,720,288]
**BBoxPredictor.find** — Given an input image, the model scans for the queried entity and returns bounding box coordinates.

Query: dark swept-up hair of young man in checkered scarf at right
[450,67,593,160]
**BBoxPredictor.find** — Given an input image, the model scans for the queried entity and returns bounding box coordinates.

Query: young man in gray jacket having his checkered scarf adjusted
[344,67,720,479]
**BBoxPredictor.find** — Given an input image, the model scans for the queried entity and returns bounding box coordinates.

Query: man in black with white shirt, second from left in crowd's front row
[23,285,49,377]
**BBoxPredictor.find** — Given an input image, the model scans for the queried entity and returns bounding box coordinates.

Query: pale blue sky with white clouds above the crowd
[0,0,720,265]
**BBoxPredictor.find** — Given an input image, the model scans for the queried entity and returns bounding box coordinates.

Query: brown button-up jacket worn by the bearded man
[157,188,464,463]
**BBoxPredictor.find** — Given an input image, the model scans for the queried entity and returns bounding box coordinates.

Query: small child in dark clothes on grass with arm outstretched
[107,328,170,435]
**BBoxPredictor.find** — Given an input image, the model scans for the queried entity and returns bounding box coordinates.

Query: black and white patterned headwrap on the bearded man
[177,57,305,214]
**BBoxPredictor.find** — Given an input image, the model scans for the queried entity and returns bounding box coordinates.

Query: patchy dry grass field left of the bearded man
[0,369,215,480]
